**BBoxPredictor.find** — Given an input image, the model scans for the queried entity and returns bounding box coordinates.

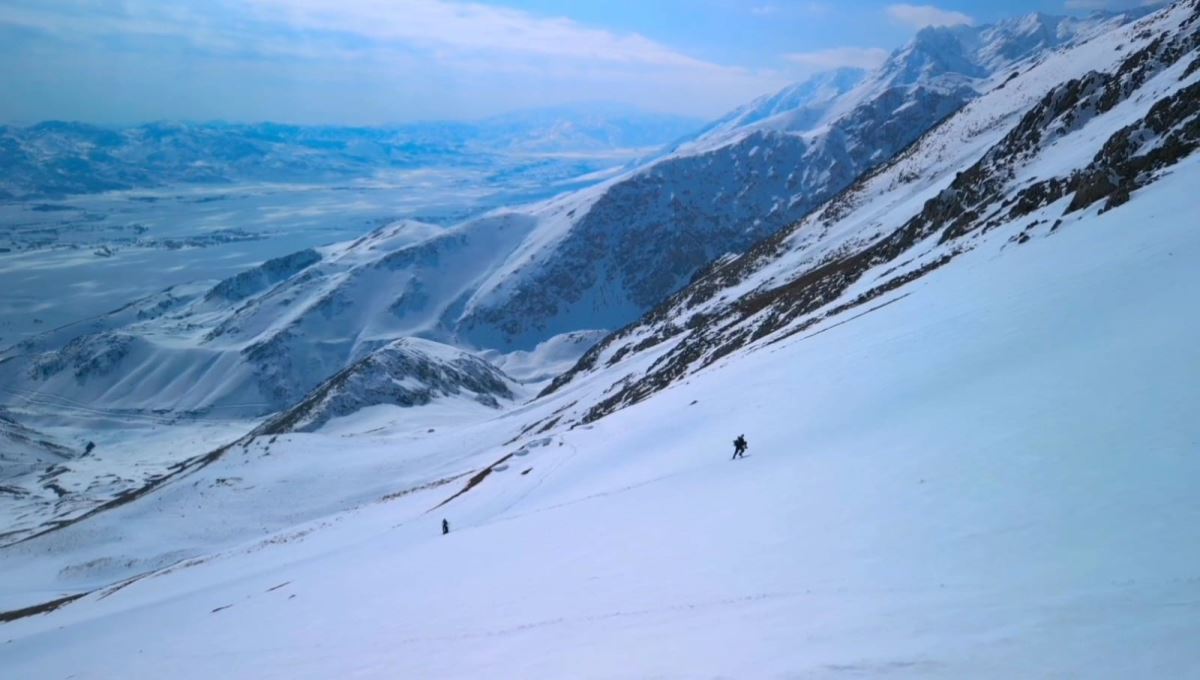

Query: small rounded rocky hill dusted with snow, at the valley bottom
[256,338,521,434]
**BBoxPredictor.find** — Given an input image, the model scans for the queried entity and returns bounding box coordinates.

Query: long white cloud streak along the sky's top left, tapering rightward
[0,0,736,71]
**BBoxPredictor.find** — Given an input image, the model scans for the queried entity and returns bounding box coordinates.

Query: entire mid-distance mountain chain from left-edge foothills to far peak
[0,9,1147,426]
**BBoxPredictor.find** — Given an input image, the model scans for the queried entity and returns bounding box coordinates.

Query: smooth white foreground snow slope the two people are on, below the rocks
[0,122,1200,679]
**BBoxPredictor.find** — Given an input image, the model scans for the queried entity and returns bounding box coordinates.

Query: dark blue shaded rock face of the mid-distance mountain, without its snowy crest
[462,88,974,347]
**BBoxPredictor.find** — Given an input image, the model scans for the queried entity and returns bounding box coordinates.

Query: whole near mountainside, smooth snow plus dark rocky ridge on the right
[0,0,1200,679]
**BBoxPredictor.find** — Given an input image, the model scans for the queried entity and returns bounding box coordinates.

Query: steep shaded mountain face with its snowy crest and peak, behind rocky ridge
[446,9,1128,349]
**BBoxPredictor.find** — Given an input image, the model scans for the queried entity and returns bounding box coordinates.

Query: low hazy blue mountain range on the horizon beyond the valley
[0,104,700,200]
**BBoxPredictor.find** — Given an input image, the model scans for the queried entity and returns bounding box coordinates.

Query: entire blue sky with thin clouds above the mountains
[0,0,1161,125]
